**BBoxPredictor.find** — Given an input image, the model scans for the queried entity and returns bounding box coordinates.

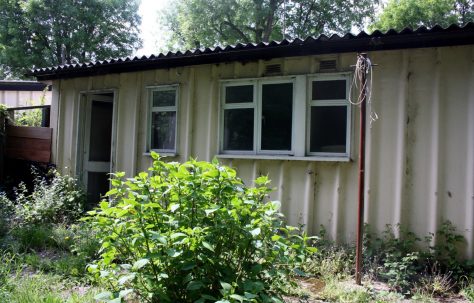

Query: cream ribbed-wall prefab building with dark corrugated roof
[29,24,474,258]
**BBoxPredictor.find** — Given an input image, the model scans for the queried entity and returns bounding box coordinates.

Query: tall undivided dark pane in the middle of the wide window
[261,83,293,150]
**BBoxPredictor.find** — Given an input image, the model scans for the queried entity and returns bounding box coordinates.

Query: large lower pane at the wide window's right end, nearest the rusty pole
[310,106,347,153]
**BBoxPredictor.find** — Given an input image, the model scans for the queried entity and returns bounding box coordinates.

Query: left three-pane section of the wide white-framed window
[221,79,294,154]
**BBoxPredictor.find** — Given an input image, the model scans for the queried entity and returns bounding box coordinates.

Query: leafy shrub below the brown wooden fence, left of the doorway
[13,171,85,225]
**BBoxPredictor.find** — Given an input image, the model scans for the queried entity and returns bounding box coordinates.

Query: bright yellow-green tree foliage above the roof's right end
[370,0,474,30]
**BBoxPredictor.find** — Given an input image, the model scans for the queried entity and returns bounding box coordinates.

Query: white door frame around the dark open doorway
[75,89,118,191]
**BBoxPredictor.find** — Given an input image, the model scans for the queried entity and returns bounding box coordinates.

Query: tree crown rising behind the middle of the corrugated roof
[162,0,378,48]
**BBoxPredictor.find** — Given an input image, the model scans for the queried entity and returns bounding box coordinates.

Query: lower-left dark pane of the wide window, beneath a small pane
[224,108,254,150]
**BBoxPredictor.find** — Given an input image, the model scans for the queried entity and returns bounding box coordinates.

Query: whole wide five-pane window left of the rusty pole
[220,73,351,160]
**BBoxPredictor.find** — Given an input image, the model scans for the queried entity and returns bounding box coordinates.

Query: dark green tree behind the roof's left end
[0,0,141,77]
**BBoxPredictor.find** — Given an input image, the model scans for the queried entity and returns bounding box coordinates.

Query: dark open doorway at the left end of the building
[78,92,115,209]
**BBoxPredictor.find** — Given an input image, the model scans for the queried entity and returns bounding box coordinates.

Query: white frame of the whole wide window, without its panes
[217,72,353,162]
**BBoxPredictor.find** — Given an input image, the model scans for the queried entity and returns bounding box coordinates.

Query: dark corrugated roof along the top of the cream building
[29,22,474,80]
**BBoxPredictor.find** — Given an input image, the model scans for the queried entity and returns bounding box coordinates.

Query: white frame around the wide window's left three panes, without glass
[219,76,296,156]
